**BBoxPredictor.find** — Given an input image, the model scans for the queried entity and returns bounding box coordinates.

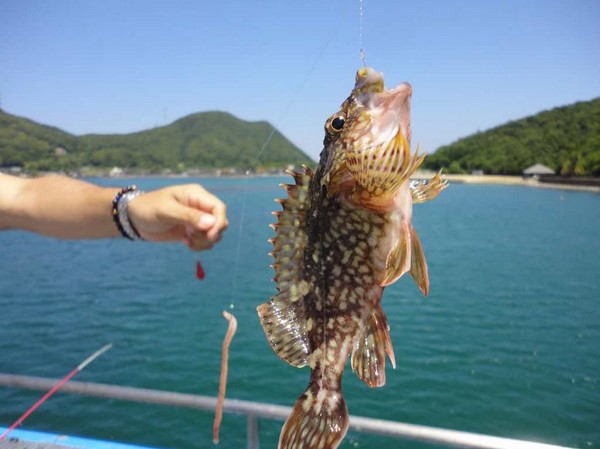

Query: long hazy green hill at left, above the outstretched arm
[0,110,312,172]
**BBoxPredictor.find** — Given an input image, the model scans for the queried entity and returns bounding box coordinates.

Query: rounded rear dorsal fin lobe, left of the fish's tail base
[257,296,310,368]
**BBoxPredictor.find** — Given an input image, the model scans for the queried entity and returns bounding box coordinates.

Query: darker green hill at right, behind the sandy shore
[424,98,600,176]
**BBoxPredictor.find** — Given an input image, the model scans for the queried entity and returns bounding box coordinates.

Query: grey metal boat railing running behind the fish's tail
[0,373,568,449]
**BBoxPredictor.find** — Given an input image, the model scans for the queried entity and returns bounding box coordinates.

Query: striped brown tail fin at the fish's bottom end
[278,376,350,449]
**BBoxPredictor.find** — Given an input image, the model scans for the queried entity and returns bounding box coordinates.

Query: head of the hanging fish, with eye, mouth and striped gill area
[320,67,422,208]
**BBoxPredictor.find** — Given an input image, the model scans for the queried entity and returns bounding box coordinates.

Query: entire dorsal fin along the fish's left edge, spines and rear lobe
[257,167,313,367]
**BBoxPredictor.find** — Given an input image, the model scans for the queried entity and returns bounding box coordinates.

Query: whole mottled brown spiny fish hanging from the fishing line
[257,67,447,449]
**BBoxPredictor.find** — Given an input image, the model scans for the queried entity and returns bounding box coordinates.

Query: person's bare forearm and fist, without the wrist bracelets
[0,173,227,250]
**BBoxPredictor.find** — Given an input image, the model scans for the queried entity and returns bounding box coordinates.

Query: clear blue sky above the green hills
[0,0,600,160]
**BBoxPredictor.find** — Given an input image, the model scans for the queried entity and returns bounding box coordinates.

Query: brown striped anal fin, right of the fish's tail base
[351,306,396,387]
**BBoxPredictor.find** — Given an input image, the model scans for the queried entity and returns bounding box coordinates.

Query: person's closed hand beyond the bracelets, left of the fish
[127,184,228,251]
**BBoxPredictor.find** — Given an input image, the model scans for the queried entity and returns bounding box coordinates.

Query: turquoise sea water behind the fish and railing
[0,178,600,449]
